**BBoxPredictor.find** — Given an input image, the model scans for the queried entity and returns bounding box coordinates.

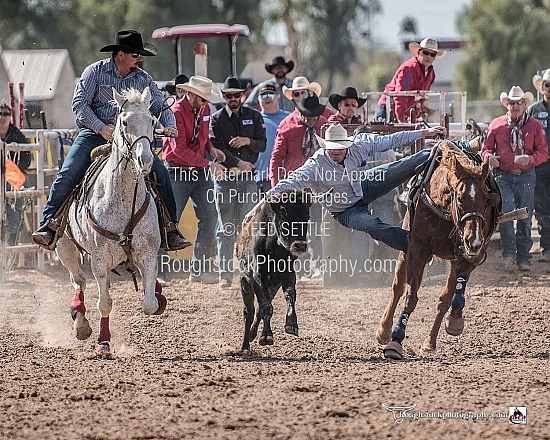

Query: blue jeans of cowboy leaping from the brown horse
[332,149,430,252]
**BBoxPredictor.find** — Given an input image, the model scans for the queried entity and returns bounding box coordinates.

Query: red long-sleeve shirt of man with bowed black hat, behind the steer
[269,110,328,186]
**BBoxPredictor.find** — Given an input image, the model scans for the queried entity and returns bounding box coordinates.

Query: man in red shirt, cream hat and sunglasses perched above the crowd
[374,37,447,122]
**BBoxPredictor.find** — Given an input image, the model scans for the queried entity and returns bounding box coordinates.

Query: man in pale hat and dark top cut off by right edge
[527,69,550,262]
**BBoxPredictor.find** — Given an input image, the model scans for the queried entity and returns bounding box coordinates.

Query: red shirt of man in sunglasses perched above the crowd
[378,56,435,122]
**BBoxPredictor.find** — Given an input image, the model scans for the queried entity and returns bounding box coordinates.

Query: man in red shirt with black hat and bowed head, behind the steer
[269,90,328,186]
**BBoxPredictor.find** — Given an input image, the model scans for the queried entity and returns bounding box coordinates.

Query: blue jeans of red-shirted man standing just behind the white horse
[161,163,218,275]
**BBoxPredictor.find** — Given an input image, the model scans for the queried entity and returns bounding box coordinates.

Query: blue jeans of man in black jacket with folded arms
[214,173,259,280]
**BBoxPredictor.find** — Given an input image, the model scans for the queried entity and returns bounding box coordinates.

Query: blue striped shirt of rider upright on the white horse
[73,58,176,133]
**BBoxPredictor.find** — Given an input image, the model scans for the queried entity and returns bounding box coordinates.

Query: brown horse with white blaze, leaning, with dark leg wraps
[376,141,501,360]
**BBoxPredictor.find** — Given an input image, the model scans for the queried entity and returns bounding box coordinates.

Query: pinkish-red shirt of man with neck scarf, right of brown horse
[481,115,548,172]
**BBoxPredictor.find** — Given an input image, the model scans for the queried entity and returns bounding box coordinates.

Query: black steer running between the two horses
[237,192,312,353]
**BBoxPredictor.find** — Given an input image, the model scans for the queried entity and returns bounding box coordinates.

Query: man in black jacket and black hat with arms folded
[212,77,266,289]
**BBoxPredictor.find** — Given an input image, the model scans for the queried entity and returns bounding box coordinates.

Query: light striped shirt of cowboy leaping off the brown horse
[267,130,422,212]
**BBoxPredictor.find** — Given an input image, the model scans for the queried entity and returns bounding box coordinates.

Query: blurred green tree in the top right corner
[457,0,550,99]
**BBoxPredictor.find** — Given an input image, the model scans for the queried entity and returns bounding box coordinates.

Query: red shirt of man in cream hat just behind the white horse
[162,97,212,168]
